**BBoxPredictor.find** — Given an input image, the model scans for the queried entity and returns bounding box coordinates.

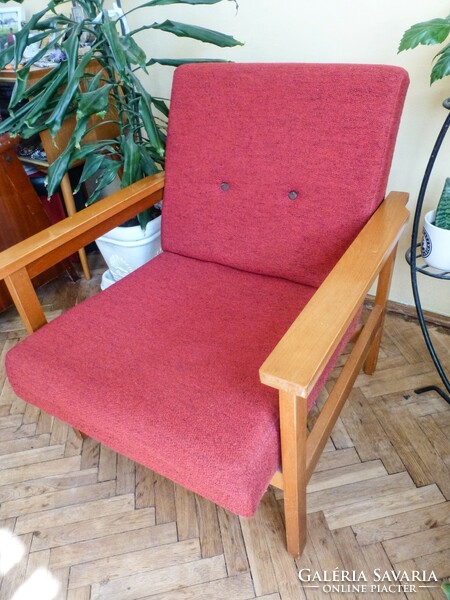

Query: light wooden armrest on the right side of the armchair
[260,192,409,398]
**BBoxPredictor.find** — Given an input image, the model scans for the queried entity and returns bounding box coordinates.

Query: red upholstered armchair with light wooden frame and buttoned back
[0,64,408,555]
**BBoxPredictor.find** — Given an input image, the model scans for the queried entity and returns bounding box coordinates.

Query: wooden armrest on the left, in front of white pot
[0,173,164,279]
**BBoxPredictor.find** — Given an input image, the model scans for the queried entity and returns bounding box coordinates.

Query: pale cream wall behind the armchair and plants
[15,0,450,316]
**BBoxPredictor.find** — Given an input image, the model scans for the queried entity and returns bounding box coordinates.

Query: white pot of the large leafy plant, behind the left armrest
[95,217,161,290]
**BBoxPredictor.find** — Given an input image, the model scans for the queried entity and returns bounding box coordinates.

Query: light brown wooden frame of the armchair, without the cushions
[0,173,409,556]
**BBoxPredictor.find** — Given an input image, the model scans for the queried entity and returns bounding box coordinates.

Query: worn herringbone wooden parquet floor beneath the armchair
[0,255,450,600]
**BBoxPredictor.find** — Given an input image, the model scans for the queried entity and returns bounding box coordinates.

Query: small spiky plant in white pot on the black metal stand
[422,177,450,271]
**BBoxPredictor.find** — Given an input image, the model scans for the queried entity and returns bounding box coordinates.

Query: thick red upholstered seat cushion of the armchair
[7,253,352,516]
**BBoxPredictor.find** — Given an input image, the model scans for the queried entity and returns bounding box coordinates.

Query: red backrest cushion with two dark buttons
[162,64,408,286]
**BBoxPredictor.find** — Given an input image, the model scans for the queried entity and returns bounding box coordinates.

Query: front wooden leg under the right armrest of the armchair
[280,391,307,557]
